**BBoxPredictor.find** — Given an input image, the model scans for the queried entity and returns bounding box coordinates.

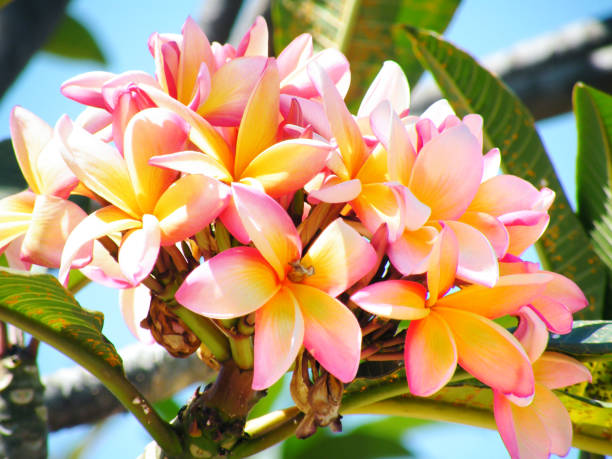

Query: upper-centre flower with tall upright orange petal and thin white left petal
[144,60,331,243]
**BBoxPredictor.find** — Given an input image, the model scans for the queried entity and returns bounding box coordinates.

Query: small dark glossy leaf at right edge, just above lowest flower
[548,320,612,358]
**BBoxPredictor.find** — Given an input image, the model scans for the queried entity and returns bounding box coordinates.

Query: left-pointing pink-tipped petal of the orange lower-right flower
[351,280,429,320]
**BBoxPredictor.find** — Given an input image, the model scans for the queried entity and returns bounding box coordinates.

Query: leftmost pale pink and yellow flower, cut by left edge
[0,107,87,268]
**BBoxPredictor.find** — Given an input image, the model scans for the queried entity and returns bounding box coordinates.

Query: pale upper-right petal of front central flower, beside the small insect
[301,218,377,297]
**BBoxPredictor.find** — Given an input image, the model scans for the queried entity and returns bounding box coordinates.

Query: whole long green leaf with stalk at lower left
[0,268,181,453]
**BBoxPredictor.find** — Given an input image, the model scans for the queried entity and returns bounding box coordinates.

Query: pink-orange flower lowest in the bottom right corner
[494,307,591,459]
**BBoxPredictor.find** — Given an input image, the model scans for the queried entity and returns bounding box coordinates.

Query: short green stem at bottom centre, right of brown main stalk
[230,406,303,458]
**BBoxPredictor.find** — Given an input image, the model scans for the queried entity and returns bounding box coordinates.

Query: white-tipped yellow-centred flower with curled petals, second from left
[57,108,227,287]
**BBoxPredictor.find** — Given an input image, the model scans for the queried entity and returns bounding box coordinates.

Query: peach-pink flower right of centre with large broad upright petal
[366,102,500,287]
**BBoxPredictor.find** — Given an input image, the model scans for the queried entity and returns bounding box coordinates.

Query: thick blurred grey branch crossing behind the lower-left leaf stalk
[43,345,215,431]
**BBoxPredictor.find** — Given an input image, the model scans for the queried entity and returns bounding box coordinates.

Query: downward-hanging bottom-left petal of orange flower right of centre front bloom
[404,311,457,397]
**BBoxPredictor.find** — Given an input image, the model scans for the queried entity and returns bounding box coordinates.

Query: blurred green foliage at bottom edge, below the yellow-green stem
[281,417,427,459]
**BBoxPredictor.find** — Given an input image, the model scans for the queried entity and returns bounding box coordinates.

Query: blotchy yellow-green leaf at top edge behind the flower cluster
[272,0,459,103]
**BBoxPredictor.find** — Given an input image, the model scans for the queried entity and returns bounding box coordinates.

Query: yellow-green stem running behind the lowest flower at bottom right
[346,395,612,454]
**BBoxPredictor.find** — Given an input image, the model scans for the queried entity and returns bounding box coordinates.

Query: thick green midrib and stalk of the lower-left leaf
[0,308,182,456]
